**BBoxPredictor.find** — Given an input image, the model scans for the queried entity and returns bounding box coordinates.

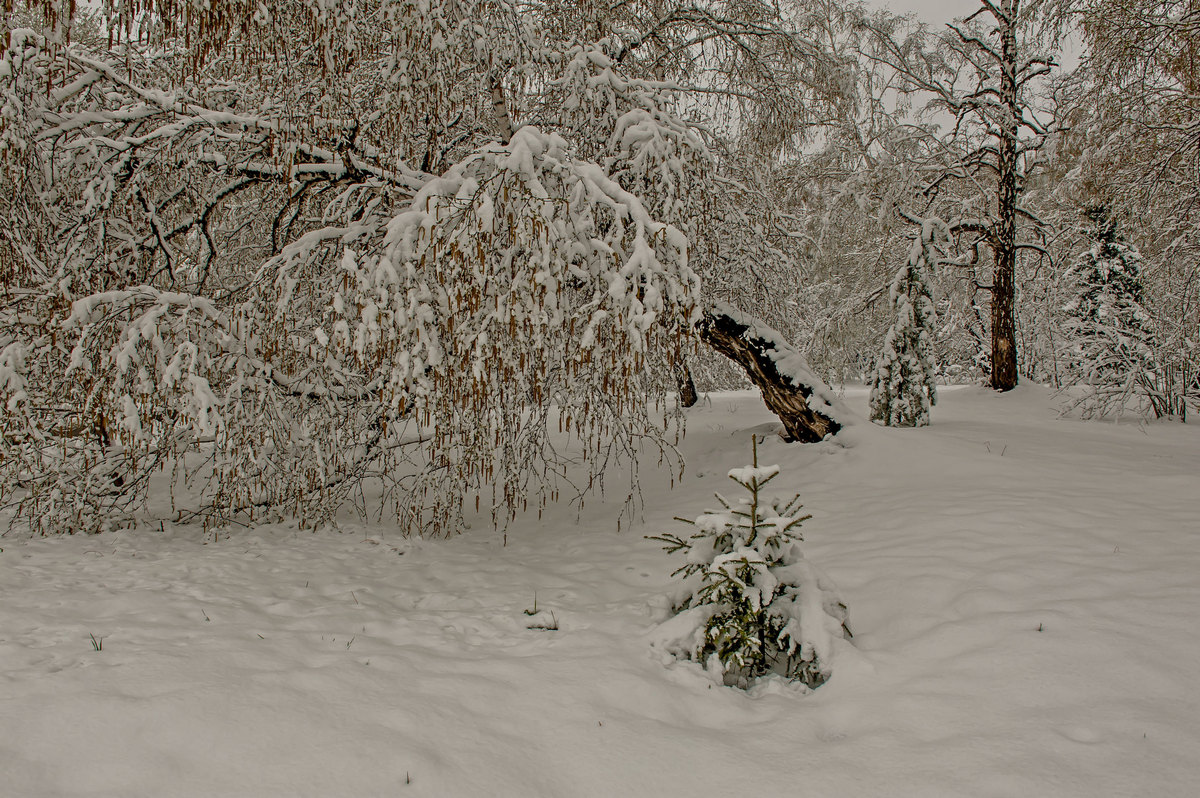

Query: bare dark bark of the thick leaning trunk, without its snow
[697,307,841,443]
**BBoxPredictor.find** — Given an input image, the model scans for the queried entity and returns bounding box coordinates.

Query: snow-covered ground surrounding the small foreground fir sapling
[0,386,1200,798]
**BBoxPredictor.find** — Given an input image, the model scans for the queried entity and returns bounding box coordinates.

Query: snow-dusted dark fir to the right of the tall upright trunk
[1063,208,1158,418]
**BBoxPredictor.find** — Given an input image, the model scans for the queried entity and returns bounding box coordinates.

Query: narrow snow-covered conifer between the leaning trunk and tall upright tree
[870,223,937,427]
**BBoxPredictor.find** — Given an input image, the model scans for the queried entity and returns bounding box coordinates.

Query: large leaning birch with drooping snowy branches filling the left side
[0,0,854,534]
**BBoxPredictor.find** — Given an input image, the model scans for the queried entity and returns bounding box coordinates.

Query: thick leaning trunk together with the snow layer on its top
[696,302,846,443]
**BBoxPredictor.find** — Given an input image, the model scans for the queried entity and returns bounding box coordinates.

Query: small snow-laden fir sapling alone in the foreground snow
[650,440,850,688]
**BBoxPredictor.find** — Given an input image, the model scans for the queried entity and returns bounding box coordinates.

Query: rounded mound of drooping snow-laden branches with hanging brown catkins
[320,126,700,532]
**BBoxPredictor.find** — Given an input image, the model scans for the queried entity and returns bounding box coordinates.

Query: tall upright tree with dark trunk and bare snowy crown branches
[872,0,1056,391]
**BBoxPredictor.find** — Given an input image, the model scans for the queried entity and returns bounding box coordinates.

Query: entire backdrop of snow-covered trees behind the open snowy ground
[0,0,1200,534]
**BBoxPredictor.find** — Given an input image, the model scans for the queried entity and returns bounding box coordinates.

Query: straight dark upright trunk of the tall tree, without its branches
[990,0,1021,391]
